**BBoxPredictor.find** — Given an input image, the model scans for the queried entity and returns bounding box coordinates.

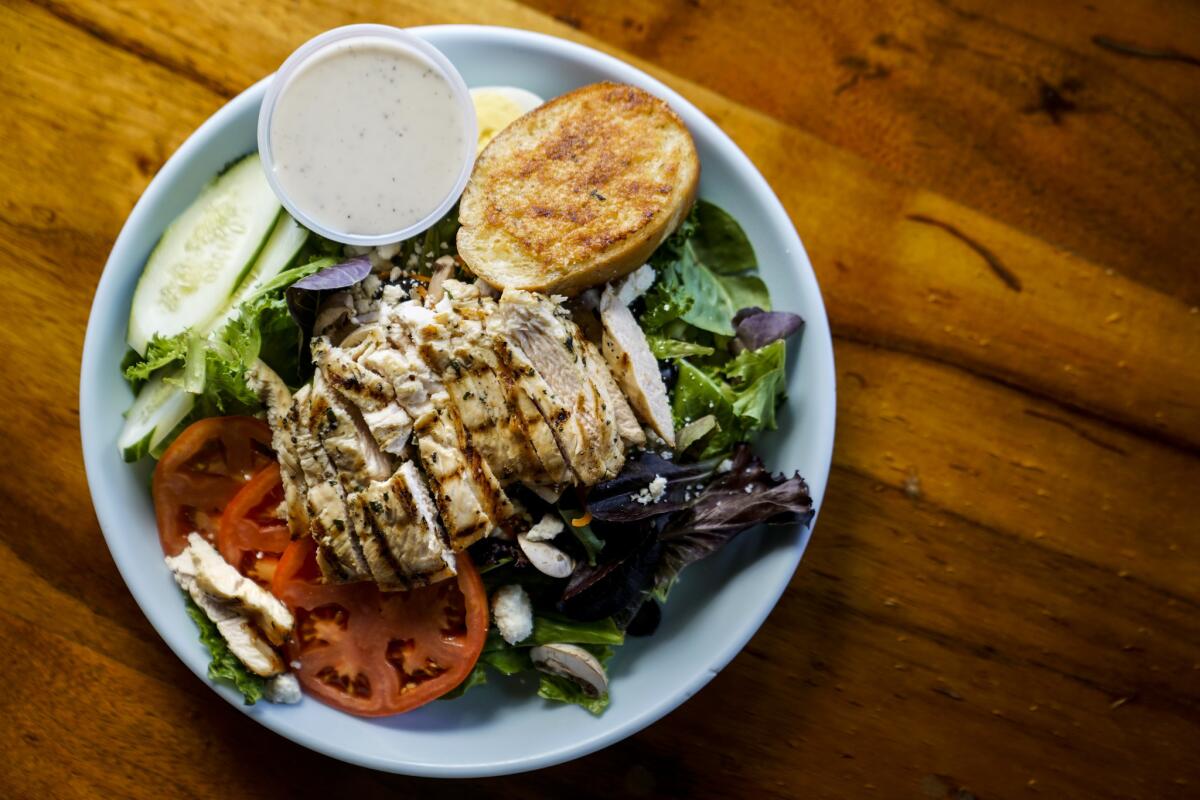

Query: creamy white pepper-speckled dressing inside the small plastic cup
[270,37,466,236]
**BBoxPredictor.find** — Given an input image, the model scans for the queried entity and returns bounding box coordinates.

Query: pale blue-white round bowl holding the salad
[79,25,834,777]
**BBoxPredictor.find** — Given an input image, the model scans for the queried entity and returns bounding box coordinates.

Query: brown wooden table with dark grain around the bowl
[0,0,1200,800]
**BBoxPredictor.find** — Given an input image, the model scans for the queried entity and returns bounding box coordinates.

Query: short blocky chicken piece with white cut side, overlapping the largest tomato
[362,462,456,588]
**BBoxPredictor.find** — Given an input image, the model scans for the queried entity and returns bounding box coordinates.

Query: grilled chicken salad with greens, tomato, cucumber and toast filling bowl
[119,70,812,716]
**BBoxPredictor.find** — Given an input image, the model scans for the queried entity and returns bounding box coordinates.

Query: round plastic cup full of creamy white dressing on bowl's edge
[258,25,476,246]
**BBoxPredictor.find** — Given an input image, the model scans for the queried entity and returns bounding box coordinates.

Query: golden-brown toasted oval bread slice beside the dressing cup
[458,83,700,294]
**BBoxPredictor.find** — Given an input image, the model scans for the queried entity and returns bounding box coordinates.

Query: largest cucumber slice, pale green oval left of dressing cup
[128,154,282,353]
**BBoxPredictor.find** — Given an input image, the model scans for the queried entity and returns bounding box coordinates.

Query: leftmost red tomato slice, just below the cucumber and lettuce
[152,416,275,555]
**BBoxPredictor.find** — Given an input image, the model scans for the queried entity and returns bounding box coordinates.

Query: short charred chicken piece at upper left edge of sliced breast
[311,329,413,455]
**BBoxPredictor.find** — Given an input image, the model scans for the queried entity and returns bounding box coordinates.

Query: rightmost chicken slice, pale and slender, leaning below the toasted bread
[600,284,674,447]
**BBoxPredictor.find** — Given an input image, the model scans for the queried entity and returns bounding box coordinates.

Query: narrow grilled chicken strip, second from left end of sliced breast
[293,381,371,583]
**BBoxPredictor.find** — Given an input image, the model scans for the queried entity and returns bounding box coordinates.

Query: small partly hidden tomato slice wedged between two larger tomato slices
[217,462,292,585]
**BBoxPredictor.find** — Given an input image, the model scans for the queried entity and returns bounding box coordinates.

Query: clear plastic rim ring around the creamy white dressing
[258,24,476,246]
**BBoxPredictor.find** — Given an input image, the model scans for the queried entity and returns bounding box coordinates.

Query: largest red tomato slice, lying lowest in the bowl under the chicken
[271,537,487,716]
